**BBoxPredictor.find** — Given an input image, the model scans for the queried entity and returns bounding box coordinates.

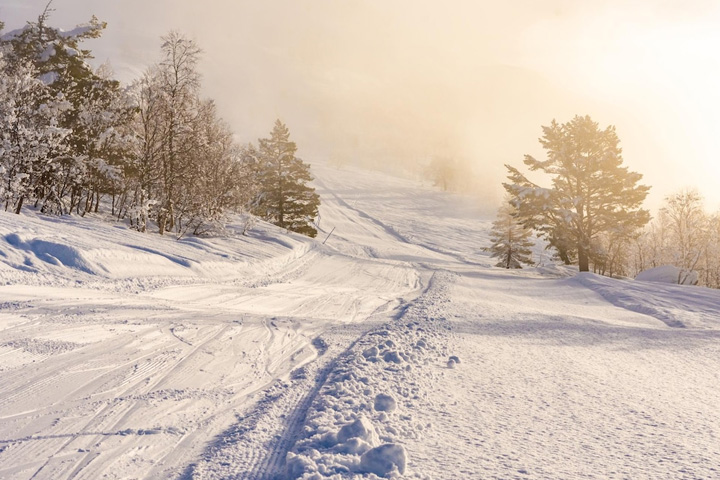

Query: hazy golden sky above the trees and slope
[0,0,720,210]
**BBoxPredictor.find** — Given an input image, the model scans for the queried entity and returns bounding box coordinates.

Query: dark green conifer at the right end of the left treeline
[254,120,320,237]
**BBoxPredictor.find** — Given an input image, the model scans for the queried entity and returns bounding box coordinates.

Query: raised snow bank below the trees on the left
[0,212,316,290]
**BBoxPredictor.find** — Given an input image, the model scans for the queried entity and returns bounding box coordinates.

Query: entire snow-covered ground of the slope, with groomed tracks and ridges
[0,165,720,479]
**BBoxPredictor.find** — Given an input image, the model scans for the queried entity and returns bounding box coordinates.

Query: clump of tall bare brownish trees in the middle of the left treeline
[125,32,257,236]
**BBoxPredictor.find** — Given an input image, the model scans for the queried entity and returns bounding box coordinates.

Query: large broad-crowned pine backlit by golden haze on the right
[503,116,650,271]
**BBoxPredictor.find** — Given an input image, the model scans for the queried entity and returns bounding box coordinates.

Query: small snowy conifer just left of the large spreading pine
[483,204,534,268]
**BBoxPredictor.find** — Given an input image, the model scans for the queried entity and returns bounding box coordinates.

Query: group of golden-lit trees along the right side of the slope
[486,116,720,288]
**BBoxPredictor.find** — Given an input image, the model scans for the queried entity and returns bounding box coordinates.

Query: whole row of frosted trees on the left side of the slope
[0,9,319,236]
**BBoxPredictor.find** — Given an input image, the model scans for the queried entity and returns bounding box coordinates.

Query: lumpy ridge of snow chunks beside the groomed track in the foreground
[283,272,454,480]
